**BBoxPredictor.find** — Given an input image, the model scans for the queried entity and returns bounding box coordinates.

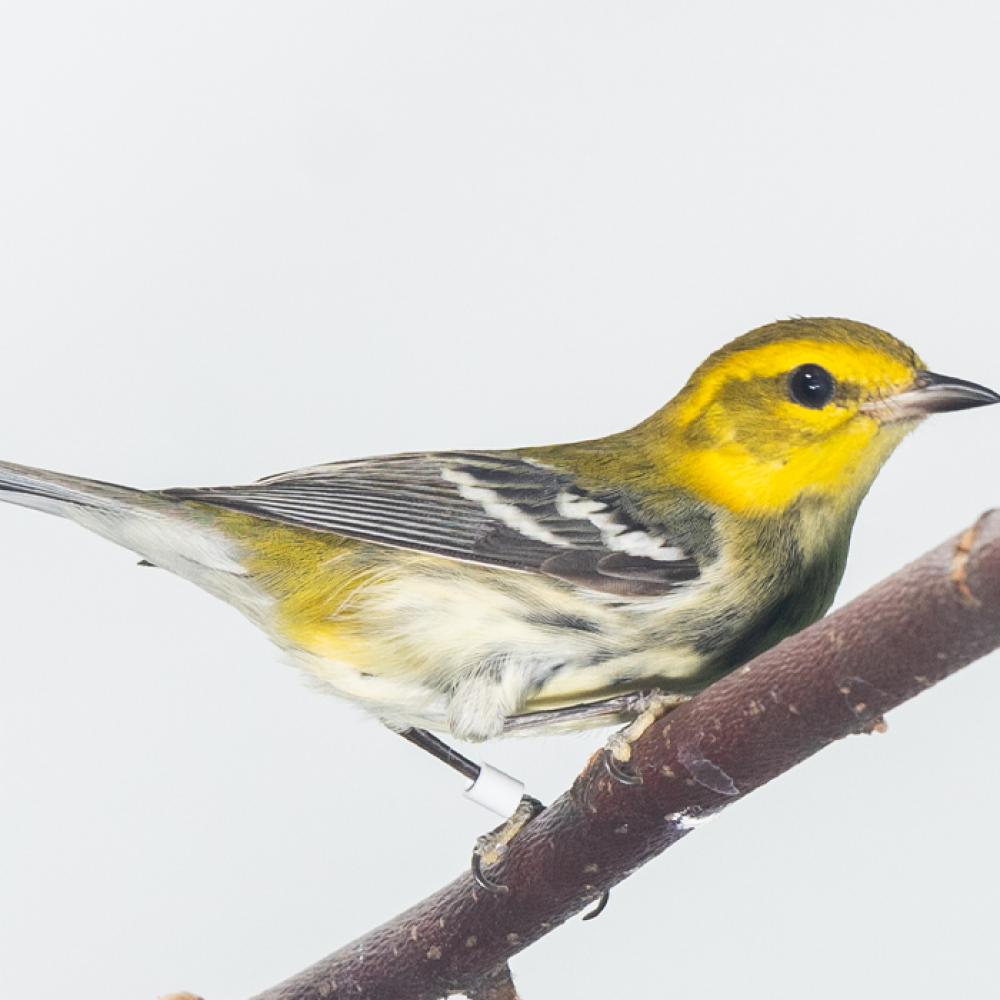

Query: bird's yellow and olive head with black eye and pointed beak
[640,319,1000,515]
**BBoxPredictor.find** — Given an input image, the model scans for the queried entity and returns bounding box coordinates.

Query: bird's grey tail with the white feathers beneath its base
[0,462,252,600]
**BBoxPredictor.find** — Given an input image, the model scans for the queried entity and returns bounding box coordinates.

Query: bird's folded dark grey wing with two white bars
[163,452,699,597]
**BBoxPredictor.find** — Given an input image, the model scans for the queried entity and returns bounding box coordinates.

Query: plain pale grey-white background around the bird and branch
[0,2,1000,1000]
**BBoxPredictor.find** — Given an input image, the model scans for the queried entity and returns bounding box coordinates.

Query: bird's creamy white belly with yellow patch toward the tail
[258,546,724,739]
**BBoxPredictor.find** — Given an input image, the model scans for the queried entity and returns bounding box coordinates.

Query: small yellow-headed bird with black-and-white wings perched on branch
[0,318,1000,888]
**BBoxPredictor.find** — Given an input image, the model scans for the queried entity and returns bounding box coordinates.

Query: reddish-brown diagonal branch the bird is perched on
[246,512,1000,1000]
